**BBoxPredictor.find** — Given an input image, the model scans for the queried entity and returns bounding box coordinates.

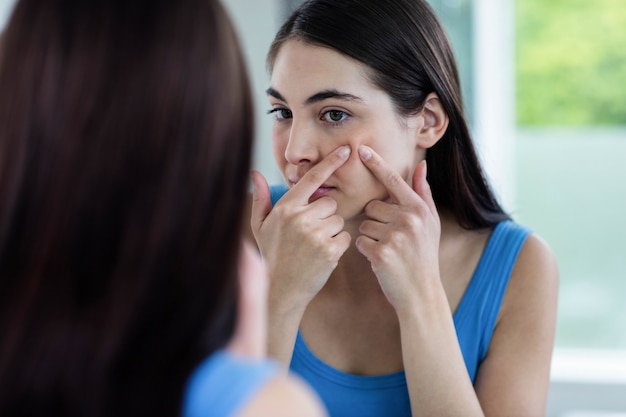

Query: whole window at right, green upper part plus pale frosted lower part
[514,0,626,349]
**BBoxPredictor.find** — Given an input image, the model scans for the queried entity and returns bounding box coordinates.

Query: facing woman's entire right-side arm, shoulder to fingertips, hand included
[356,145,558,417]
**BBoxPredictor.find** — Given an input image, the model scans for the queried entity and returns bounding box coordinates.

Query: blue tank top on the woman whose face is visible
[271,186,530,417]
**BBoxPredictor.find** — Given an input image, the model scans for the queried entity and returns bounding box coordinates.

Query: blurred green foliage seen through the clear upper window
[516,0,626,126]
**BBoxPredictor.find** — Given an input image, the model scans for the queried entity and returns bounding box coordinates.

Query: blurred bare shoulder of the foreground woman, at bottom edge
[237,374,328,417]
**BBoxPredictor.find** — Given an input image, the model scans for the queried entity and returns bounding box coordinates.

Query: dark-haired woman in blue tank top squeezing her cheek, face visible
[251,0,558,417]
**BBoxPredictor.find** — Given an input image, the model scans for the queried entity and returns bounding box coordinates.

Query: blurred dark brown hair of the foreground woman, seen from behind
[0,0,253,416]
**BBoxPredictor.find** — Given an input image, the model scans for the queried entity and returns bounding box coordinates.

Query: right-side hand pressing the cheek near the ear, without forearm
[356,145,441,311]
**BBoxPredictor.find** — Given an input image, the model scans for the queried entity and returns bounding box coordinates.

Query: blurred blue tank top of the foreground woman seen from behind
[182,350,280,417]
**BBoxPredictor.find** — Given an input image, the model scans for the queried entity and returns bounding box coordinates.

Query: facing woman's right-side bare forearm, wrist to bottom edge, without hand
[398,288,484,417]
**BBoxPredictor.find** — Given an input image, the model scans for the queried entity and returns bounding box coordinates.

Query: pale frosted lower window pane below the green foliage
[515,128,626,349]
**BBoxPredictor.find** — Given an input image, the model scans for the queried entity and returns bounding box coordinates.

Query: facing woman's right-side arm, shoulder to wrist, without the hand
[399,235,558,417]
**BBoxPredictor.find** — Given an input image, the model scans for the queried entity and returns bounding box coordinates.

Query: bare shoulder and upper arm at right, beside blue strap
[475,234,559,416]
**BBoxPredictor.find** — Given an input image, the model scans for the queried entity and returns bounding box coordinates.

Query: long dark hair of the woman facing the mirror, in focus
[267,0,508,229]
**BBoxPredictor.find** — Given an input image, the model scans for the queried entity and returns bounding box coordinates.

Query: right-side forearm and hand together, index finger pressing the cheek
[356,147,483,417]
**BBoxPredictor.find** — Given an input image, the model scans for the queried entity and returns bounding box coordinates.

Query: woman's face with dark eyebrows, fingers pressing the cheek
[267,40,425,220]
